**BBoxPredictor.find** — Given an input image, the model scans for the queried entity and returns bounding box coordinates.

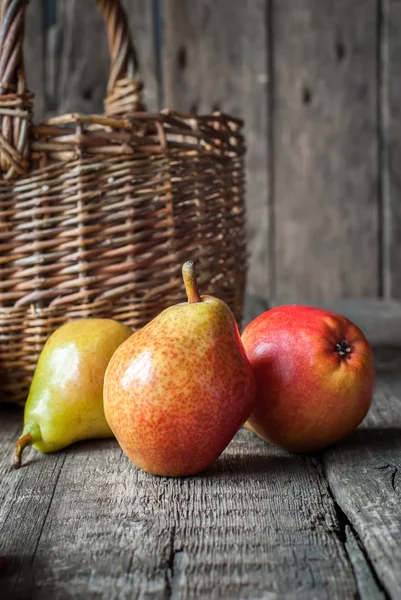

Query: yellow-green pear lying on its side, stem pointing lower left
[13,318,132,469]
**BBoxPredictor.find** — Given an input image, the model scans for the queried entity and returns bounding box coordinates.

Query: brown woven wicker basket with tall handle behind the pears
[0,0,246,403]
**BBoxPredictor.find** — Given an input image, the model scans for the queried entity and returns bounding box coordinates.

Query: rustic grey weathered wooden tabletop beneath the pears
[0,302,401,600]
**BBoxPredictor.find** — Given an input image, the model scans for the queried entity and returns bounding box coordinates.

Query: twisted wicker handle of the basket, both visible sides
[0,0,144,179]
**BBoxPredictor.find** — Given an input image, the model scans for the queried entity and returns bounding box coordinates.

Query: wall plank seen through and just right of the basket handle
[25,0,160,120]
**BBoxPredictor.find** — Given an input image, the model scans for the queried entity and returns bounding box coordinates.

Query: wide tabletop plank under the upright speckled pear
[0,408,356,600]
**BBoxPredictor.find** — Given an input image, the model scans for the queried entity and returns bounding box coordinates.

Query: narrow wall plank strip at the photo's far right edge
[380,0,401,298]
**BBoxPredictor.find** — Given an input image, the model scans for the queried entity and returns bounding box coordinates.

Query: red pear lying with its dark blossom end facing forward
[242,305,375,452]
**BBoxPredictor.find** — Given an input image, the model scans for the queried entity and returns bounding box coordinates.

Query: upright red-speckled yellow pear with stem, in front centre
[104,262,255,476]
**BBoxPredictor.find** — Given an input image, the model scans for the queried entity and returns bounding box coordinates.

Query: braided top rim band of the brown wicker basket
[0,110,246,186]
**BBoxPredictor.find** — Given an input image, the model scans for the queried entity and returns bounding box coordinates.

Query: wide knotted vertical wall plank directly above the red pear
[272,0,379,301]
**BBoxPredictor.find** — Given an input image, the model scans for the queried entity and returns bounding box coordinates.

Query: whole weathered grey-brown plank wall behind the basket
[22,0,401,302]
